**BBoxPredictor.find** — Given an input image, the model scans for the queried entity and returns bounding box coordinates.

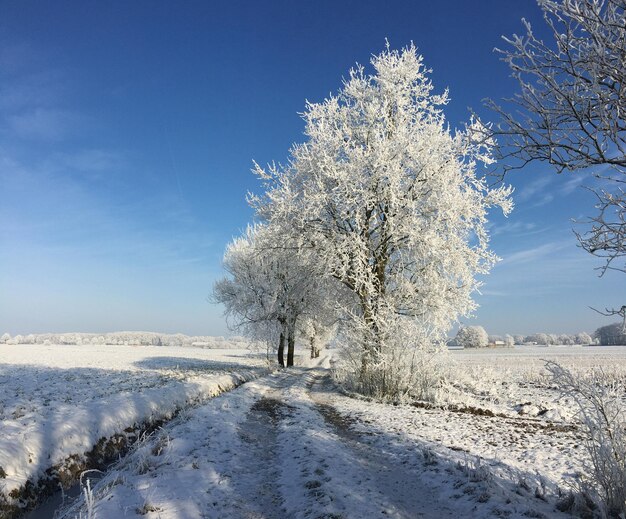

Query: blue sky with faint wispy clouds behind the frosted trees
[0,0,626,335]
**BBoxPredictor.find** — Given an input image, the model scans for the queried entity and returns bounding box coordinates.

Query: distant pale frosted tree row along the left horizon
[0,332,250,348]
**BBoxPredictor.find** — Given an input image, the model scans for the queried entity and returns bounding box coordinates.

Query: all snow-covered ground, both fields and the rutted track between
[0,346,626,519]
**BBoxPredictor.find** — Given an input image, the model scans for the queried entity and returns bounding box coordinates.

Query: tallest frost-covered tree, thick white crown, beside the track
[251,45,511,393]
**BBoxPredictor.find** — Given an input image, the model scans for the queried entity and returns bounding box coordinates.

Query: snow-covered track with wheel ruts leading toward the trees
[58,369,559,519]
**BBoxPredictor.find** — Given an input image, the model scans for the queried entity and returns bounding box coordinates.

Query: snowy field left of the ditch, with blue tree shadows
[0,344,266,515]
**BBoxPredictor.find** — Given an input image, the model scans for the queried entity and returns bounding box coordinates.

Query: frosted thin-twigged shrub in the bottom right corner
[546,361,626,517]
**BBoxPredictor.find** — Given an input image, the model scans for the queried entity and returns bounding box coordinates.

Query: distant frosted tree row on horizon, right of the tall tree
[453,326,592,348]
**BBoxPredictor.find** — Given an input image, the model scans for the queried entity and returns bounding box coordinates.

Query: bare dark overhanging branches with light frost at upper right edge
[489,0,626,315]
